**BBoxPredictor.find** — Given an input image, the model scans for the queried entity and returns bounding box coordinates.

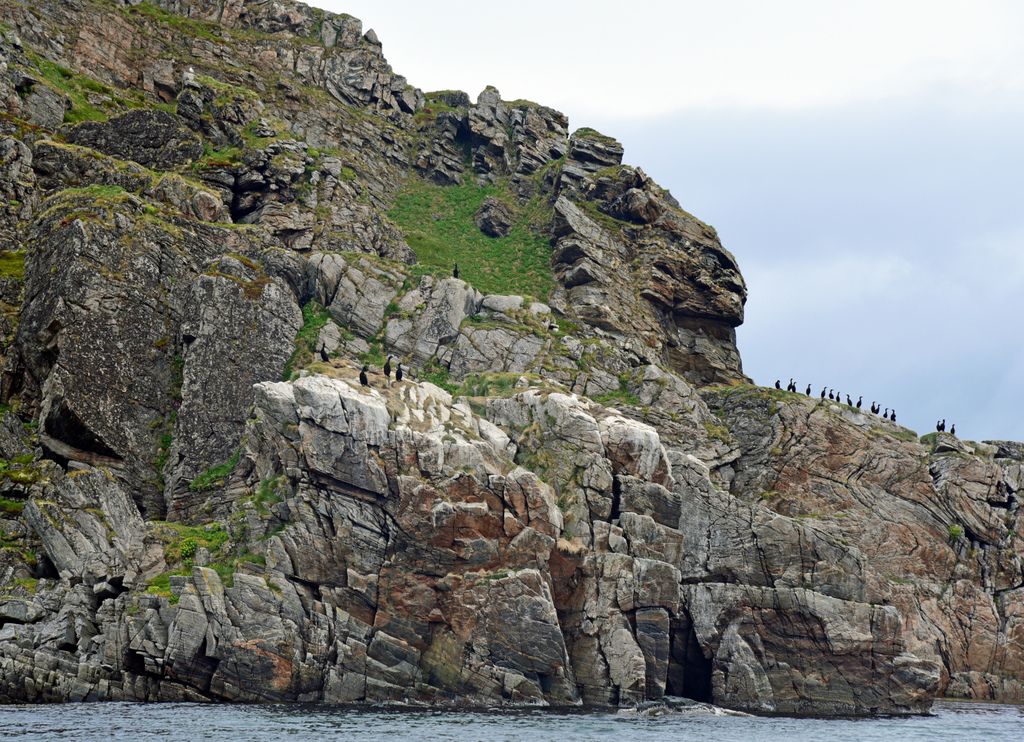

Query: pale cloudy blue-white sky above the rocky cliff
[313,0,1024,440]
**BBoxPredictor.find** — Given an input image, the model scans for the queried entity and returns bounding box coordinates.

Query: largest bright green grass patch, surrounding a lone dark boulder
[388,177,554,299]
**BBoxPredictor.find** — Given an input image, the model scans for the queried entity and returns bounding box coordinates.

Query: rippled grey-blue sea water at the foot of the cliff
[0,701,1024,742]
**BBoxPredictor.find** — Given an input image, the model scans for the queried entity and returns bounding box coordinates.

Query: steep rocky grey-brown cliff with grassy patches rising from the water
[0,0,1024,714]
